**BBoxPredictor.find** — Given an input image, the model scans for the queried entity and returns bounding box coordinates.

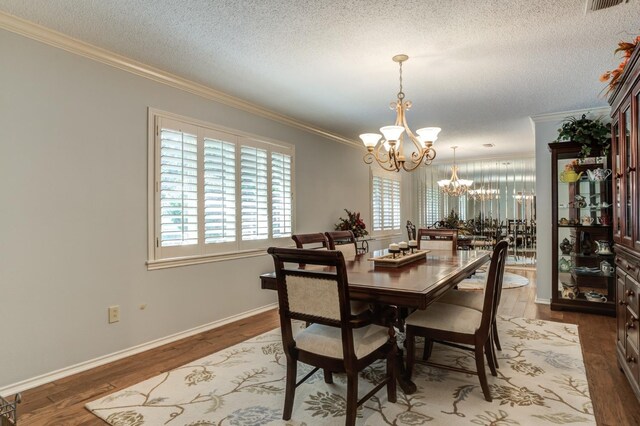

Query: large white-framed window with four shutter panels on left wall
[149,110,293,265]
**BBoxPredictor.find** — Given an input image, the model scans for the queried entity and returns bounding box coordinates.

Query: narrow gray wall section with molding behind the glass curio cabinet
[532,108,609,303]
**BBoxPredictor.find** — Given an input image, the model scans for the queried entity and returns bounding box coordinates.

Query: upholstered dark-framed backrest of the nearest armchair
[267,247,355,360]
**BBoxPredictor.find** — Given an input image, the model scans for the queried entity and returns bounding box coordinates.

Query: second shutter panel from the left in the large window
[204,137,236,244]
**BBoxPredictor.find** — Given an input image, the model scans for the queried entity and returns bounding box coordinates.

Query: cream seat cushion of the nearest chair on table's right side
[405,302,482,334]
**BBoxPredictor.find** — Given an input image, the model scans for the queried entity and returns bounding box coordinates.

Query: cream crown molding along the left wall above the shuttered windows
[0,11,362,148]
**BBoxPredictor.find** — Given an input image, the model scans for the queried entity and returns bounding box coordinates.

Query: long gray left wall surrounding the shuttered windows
[0,30,409,389]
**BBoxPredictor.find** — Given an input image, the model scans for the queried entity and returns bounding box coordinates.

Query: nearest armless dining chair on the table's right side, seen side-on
[405,241,509,402]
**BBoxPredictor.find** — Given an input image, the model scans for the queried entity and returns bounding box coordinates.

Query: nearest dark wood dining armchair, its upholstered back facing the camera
[267,247,397,425]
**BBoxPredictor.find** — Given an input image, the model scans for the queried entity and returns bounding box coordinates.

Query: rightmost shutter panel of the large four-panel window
[271,152,293,238]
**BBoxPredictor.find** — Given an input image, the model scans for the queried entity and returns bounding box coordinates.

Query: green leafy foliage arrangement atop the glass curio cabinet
[554,114,611,158]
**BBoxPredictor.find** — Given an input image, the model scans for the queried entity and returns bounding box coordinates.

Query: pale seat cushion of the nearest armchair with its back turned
[295,324,389,359]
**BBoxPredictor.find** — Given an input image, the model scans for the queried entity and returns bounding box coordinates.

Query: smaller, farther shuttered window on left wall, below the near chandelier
[371,172,400,232]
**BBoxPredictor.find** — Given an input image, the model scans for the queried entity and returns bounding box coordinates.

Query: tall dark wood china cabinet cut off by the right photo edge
[609,42,640,399]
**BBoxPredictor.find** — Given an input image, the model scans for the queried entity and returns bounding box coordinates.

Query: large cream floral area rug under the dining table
[87,317,595,426]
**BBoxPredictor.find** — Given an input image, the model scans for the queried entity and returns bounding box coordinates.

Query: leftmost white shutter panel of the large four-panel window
[158,128,198,247]
